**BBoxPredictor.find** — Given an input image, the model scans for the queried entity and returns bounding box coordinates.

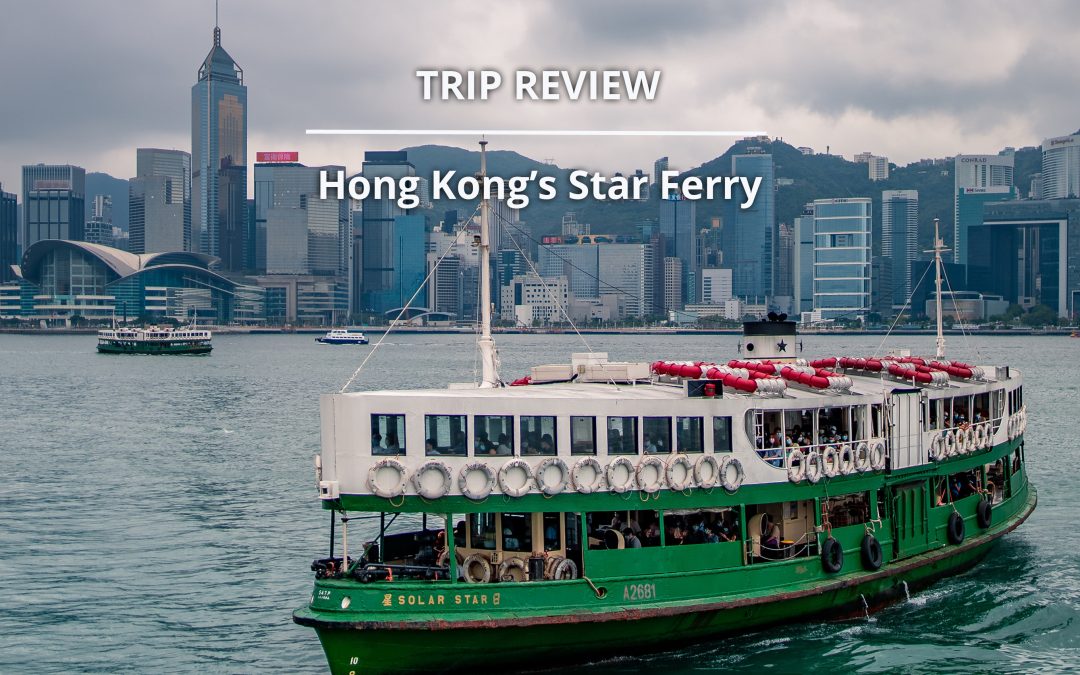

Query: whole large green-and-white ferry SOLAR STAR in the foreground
[293,143,1036,674]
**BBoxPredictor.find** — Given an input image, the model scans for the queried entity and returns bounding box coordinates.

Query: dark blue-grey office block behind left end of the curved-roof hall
[22,164,86,251]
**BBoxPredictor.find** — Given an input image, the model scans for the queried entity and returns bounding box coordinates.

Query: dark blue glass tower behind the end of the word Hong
[352,151,427,314]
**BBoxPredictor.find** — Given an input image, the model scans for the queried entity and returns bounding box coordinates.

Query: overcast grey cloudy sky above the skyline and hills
[0,0,1080,192]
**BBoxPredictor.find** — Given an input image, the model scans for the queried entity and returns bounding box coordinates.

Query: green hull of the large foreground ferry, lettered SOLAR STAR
[294,476,1036,673]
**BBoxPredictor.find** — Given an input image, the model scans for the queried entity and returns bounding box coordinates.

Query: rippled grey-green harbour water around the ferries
[0,335,1080,673]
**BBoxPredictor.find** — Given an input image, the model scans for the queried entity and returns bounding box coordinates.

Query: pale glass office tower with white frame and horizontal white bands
[813,198,873,320]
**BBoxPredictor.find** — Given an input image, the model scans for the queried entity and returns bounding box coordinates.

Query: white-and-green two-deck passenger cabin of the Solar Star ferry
[312,356,1027,587]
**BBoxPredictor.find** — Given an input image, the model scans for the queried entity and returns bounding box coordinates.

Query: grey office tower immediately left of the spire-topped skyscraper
[127,148,191,253]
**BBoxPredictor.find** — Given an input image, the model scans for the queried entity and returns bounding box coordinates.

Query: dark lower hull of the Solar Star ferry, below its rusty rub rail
[294,487,1036,674]
